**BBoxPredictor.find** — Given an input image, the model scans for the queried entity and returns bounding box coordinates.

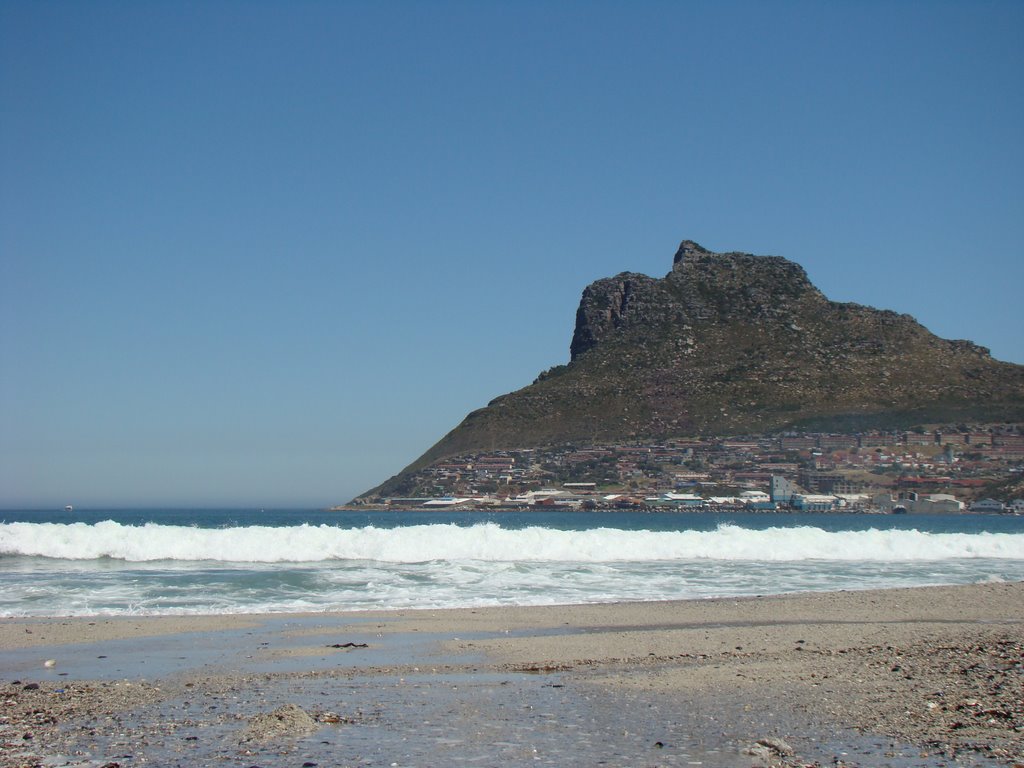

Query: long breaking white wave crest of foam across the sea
[0,520,1024,563]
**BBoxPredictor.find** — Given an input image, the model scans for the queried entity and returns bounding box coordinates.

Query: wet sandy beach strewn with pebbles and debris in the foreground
[0,583,1024,766]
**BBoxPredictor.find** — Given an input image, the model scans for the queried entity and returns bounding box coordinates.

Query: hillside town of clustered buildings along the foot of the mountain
[355,424,1024,514]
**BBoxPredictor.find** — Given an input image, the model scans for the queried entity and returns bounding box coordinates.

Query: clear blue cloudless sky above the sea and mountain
[0,0,1024,507]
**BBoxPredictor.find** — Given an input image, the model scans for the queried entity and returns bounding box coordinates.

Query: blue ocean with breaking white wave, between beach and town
[0,509,1024,617]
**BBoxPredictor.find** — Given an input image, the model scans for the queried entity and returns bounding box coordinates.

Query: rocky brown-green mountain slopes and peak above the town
[358,241,1024,501]
